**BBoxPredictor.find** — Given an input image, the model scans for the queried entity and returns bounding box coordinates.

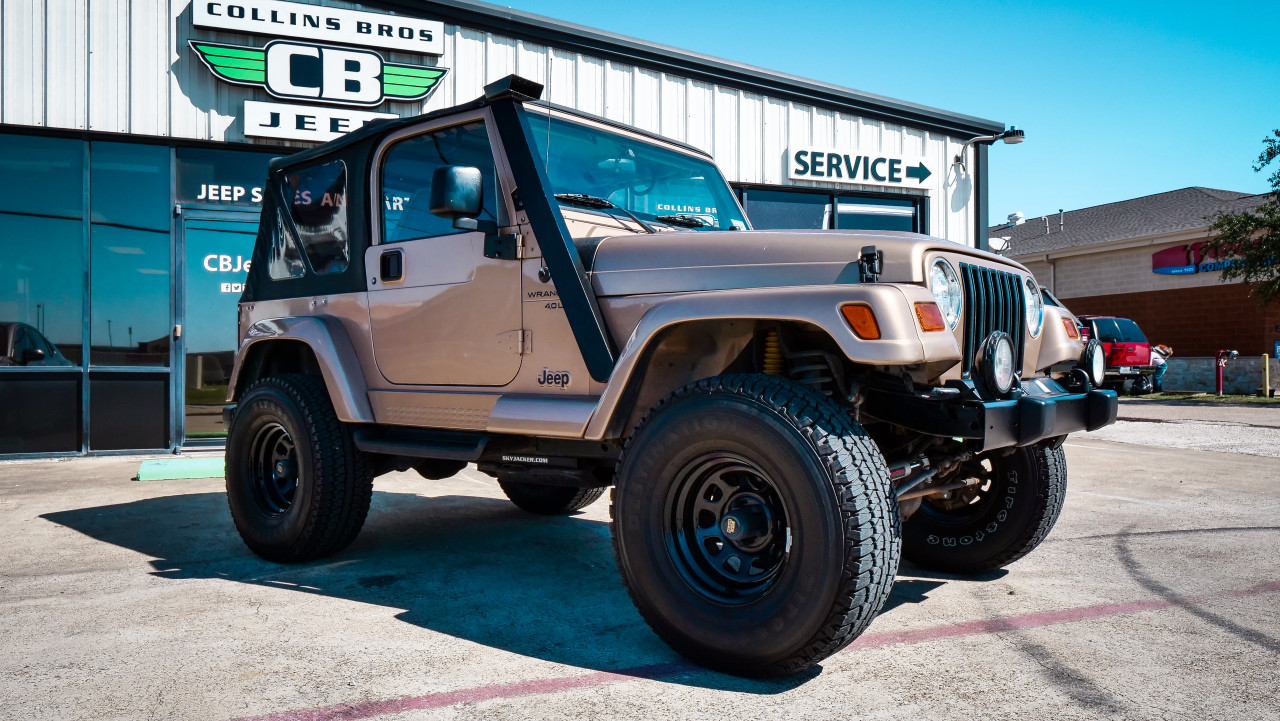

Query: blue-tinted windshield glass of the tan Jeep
[530,111,748,231]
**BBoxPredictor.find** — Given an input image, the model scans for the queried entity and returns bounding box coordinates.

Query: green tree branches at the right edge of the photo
[1207,129,1280,305]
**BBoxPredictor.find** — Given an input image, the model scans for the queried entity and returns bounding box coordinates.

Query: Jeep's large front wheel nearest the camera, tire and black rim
[612,375,900,676]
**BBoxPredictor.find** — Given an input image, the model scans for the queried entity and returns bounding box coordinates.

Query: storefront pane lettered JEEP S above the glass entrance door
[175,147,273,207]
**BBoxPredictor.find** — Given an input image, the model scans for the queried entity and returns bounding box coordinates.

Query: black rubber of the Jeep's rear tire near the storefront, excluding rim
[227,374,374,563]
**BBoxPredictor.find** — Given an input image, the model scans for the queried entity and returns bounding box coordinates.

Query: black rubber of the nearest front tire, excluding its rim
[611,375,901,677]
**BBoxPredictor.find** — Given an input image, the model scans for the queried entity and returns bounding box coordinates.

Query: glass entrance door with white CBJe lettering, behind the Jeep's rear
[178,210,257,446]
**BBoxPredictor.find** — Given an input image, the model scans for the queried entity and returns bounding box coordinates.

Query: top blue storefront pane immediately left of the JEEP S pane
[90,142,173,233]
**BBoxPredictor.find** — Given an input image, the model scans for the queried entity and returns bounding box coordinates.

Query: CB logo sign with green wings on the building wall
[189,40,448,106]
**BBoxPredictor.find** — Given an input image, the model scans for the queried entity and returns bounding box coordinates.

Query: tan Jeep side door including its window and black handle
[365,111,522,385]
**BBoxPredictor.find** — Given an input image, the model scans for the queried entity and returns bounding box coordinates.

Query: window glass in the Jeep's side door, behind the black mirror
[381,123,498,243]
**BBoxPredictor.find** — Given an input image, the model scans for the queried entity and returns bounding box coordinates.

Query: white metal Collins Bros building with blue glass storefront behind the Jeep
[0,0,1005,456]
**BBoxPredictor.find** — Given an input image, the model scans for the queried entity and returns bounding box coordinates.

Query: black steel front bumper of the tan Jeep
[863,379,1120,451]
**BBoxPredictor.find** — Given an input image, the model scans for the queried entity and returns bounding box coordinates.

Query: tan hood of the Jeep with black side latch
[579,231,1021,297]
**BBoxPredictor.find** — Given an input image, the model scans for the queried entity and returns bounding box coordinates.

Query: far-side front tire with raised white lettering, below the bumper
[902,442,1066,575]
